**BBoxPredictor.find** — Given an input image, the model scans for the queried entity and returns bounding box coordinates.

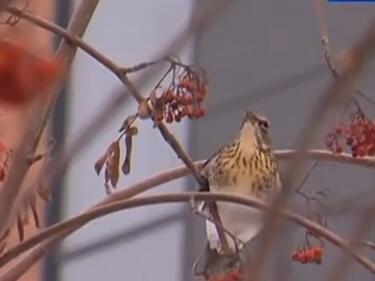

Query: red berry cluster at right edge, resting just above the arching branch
[326,112,375,157]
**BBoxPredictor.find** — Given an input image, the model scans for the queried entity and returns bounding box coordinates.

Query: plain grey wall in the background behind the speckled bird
[188,0,375,280]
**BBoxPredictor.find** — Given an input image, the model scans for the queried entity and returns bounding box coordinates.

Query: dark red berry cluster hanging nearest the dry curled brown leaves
[151,66,207,123]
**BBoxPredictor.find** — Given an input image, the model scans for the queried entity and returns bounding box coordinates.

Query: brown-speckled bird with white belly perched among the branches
[199,111,281,254]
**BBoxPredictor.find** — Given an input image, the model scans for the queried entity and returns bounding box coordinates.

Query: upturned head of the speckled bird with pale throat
[241,111,271,149]
